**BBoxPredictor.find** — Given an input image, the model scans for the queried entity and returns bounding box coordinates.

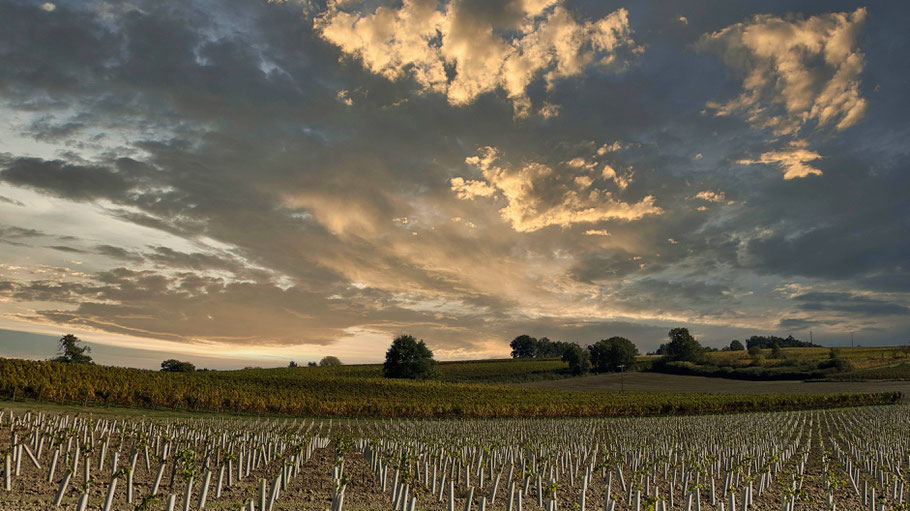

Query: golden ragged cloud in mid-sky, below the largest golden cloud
[450,147,663,232]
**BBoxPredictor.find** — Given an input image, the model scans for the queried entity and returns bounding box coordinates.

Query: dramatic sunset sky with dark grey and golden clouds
[0,0,910,368]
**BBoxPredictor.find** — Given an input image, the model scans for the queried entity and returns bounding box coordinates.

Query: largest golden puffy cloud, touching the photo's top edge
[314,0,640,118]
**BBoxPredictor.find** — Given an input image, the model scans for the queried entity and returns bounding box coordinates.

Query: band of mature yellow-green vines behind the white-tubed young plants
[0,359,900,417]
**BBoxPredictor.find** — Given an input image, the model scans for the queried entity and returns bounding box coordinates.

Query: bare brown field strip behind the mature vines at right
[522,372,910,400]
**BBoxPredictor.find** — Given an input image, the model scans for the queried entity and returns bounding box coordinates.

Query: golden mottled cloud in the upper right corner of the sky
[699,7,867,135]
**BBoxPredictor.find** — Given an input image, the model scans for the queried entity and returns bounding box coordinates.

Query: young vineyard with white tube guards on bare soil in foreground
[0,405,910,511]
